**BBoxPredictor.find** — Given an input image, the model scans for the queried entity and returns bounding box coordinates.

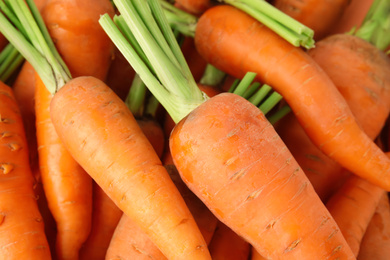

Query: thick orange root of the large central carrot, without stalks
[170,93,354,259]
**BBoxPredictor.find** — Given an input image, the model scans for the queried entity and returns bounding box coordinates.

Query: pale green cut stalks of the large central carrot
[99,0,207,122]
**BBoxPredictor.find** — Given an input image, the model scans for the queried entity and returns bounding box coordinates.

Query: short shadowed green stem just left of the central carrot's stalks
[125,74,147,118]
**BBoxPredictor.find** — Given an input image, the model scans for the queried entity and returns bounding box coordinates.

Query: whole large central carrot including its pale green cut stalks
[100,1,355,259]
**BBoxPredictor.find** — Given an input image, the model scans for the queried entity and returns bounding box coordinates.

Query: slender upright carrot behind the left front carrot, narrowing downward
[35,74,92,259]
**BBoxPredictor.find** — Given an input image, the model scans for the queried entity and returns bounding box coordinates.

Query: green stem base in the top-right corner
[353,0,390,50]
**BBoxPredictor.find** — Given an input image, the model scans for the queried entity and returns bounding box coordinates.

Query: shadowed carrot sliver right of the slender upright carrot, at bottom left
[80,183,123,260]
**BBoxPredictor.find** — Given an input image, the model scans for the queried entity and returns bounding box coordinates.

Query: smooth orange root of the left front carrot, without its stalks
[50,77,210,259]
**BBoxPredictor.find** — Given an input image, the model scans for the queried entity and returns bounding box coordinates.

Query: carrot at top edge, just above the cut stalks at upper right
[274,0,349,40]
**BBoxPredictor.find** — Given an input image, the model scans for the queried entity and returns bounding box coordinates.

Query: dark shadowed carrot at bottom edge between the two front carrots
[209,222,251,260]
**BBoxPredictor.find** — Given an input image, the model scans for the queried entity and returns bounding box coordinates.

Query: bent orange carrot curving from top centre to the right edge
[195,5,390,190]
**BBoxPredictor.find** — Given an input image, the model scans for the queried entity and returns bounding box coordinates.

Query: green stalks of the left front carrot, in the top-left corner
[0,0,71,93]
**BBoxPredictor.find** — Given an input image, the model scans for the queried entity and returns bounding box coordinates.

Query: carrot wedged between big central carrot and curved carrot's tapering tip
[326,173,390,257]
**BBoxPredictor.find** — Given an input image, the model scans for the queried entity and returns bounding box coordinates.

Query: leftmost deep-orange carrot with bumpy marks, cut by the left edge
[0,81,51,260]
